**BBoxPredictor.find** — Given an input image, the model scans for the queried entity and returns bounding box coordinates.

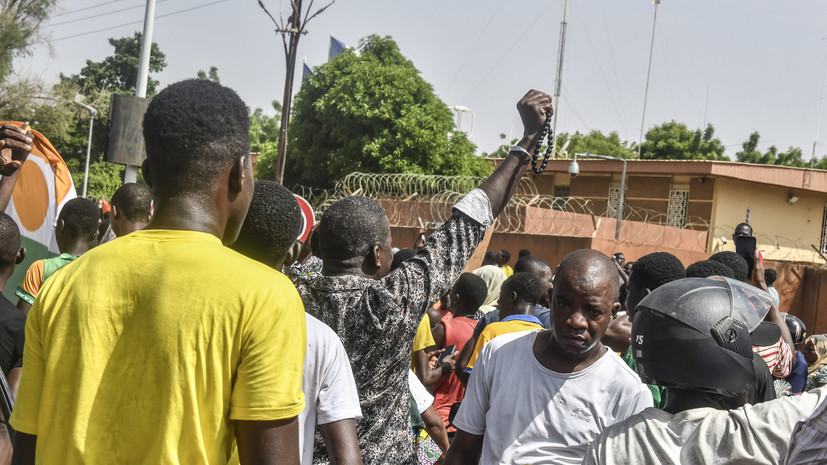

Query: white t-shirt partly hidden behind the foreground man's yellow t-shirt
[299,314,362,465]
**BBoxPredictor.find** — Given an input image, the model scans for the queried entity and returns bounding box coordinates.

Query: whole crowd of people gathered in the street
[0,80,827,465]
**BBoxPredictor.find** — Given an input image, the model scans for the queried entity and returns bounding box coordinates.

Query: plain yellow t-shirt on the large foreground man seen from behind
[11,230,306,464]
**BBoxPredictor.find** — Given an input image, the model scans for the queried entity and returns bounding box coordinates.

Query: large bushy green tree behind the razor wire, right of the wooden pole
[285,35,491,188]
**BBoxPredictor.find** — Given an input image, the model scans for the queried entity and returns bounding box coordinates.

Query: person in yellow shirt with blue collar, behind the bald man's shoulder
[465,272,544,373]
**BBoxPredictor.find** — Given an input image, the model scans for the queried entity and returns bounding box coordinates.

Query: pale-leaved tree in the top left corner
[0,0,57,83]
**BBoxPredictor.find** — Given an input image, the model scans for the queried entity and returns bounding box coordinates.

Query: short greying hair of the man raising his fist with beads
[314,195,390,261]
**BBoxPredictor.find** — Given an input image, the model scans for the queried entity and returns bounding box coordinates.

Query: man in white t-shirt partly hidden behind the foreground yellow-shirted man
[233,181,362,465]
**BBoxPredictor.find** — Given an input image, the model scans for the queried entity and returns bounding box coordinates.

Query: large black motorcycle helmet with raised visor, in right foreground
[632,277,772,396]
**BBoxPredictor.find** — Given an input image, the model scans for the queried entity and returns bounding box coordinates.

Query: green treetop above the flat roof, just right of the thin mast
[640,120,729,160]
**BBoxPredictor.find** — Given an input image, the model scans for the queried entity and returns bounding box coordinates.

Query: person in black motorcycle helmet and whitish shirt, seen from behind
[583,277,827,465]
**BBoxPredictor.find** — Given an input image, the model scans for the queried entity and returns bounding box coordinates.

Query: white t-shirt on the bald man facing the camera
[454,331,652,465]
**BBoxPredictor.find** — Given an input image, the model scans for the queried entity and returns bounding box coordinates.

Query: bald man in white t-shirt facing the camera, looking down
[445,250,652,465]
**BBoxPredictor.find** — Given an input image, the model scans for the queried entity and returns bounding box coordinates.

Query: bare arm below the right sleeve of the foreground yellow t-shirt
[235,417,300,465]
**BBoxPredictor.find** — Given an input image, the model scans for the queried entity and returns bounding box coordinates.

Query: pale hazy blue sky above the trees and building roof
[22,0,827,158]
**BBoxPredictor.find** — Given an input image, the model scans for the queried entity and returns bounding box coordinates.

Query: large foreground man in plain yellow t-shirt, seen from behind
[11,80,306,464]
